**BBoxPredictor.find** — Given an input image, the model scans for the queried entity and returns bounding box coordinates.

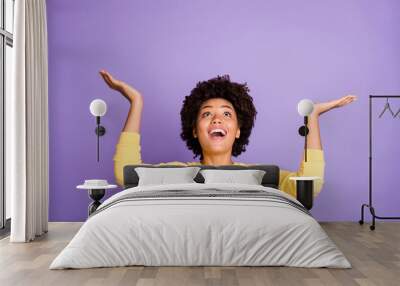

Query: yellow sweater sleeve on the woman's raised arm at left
[113,132,142,186]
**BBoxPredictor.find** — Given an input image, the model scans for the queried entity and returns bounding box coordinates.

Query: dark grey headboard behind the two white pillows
[124,164,279,189]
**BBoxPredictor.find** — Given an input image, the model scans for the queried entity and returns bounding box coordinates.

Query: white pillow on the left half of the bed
[135,167,200,186]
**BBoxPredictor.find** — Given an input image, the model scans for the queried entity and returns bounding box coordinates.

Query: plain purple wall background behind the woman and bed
[47,0,400,221]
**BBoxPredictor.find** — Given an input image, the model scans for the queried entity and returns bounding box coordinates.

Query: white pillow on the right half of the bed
[200,169,266,185]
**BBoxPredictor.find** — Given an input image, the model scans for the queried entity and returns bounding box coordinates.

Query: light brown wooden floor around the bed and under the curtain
[0,222,400,286]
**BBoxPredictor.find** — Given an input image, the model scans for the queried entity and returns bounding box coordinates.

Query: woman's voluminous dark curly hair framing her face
[181,75,257,160]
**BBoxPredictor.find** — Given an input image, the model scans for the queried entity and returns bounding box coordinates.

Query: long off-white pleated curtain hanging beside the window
[6,0,49,242]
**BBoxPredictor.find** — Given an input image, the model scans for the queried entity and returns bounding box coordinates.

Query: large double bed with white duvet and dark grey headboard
[50,165,351,269]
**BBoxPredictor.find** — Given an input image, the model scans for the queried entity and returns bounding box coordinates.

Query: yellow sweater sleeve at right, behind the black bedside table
[279,149,325,198]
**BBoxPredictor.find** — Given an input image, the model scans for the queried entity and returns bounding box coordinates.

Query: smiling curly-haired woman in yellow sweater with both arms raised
[100,70,356,196]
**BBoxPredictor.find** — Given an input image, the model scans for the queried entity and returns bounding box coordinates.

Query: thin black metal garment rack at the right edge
[359,95,400,230]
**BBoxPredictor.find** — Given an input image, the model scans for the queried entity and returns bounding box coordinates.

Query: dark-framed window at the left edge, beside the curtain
[0,0,15,233]
